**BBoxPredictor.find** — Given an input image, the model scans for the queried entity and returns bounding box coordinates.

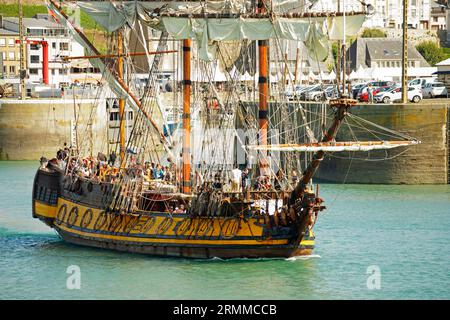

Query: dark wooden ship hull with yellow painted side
[33,169,314,259]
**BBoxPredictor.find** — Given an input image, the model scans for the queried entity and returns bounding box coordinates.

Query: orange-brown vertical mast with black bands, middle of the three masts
[182,39,191,193]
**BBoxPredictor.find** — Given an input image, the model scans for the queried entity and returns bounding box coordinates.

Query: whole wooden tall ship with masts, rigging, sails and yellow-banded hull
[33,0,418,259]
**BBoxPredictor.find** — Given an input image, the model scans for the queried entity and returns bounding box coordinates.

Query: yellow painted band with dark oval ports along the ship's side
[47,198,314,254]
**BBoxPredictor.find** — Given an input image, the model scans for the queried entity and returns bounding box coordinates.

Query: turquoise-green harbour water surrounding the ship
[0,162,450,299]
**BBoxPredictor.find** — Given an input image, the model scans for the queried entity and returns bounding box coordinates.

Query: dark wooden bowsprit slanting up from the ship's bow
[289,99,357,204]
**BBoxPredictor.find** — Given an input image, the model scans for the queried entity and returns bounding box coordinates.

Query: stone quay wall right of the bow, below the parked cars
[316,99,450,184]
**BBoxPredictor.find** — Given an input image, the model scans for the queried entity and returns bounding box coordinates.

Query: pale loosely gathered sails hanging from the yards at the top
[77,0,366,61]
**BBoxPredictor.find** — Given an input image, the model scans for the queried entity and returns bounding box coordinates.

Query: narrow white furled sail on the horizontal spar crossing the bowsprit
[247,140,420,152]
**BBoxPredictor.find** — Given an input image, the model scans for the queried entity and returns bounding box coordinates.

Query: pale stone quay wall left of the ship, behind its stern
[0,99,108,160]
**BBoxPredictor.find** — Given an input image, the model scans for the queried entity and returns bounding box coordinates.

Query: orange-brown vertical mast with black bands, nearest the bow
[257,0,269,174]
